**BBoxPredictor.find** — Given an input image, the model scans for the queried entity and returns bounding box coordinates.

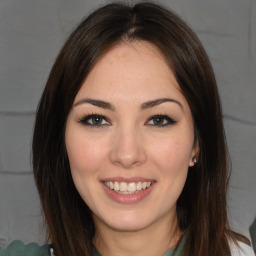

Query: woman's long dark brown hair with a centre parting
[33,3,250,256]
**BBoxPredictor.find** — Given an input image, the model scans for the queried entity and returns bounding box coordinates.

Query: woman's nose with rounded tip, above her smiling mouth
[110,126,147,169]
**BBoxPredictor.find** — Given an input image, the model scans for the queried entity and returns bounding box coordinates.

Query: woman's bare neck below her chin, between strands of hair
[93,212,181,256]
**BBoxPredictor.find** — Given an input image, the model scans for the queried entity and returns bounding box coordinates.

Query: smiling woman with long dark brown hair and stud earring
[0,3,253,256]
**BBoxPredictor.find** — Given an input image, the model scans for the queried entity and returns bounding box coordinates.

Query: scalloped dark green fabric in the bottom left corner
[0,240,54,256]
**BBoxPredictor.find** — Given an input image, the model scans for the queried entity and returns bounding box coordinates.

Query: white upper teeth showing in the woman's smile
[104,181,153,194]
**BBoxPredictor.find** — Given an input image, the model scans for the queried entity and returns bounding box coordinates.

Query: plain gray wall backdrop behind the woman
[0,0,256,248]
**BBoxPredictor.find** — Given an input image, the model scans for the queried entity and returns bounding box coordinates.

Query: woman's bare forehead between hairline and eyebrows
[76,41,184,106]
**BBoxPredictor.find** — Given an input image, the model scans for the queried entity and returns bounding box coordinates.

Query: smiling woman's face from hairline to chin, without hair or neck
[65,41,197,231]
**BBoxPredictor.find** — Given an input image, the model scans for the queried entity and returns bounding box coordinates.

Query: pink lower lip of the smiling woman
[102,183,155,204]
